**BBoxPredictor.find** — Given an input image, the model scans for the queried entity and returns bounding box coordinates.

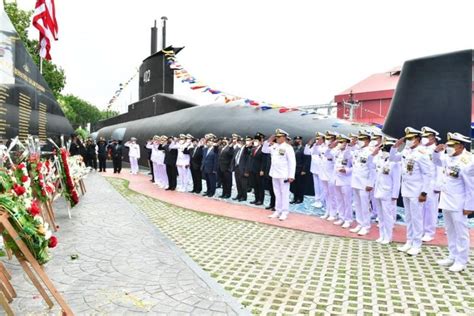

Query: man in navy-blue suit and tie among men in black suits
[201,135,219,197]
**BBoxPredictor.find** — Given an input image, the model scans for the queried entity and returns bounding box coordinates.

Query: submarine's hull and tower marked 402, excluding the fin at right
[93,22,373,165]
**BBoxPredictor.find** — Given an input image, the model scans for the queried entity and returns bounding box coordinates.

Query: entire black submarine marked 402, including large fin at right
[93,21,473,165]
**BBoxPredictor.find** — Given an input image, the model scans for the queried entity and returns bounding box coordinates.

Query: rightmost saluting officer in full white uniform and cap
[433,133,474,272]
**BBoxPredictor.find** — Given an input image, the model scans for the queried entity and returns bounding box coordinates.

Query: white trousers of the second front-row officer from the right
[403,197,423,248]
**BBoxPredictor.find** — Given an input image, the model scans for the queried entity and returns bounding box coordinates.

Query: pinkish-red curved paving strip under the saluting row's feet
[102,169,474,247]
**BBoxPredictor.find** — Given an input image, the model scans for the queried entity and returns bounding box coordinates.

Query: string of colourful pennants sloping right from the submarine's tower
[162,50,307,114]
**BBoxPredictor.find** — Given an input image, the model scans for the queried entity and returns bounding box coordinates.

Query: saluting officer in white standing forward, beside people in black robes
[262,129,296,221]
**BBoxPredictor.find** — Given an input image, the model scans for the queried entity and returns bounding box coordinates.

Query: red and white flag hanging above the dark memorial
[33,0,58,60]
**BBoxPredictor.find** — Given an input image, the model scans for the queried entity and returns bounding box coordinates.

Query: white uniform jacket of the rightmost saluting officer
[433,150,474,211]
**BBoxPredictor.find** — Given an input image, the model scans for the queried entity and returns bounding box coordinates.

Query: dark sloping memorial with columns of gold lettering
[0,10,73,144]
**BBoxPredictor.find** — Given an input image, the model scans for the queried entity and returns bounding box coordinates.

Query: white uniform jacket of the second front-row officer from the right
[390,145,433,198]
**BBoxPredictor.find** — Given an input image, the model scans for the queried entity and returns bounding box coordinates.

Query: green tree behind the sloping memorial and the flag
[3,0,66,98]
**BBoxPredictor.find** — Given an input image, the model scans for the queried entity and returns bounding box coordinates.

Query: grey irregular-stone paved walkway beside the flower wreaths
[2,174,244,315]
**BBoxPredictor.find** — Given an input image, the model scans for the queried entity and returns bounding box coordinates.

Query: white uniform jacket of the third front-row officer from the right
[374,152,401,200]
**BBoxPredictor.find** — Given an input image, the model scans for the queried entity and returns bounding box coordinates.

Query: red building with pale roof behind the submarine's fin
[334,67,400,125]
